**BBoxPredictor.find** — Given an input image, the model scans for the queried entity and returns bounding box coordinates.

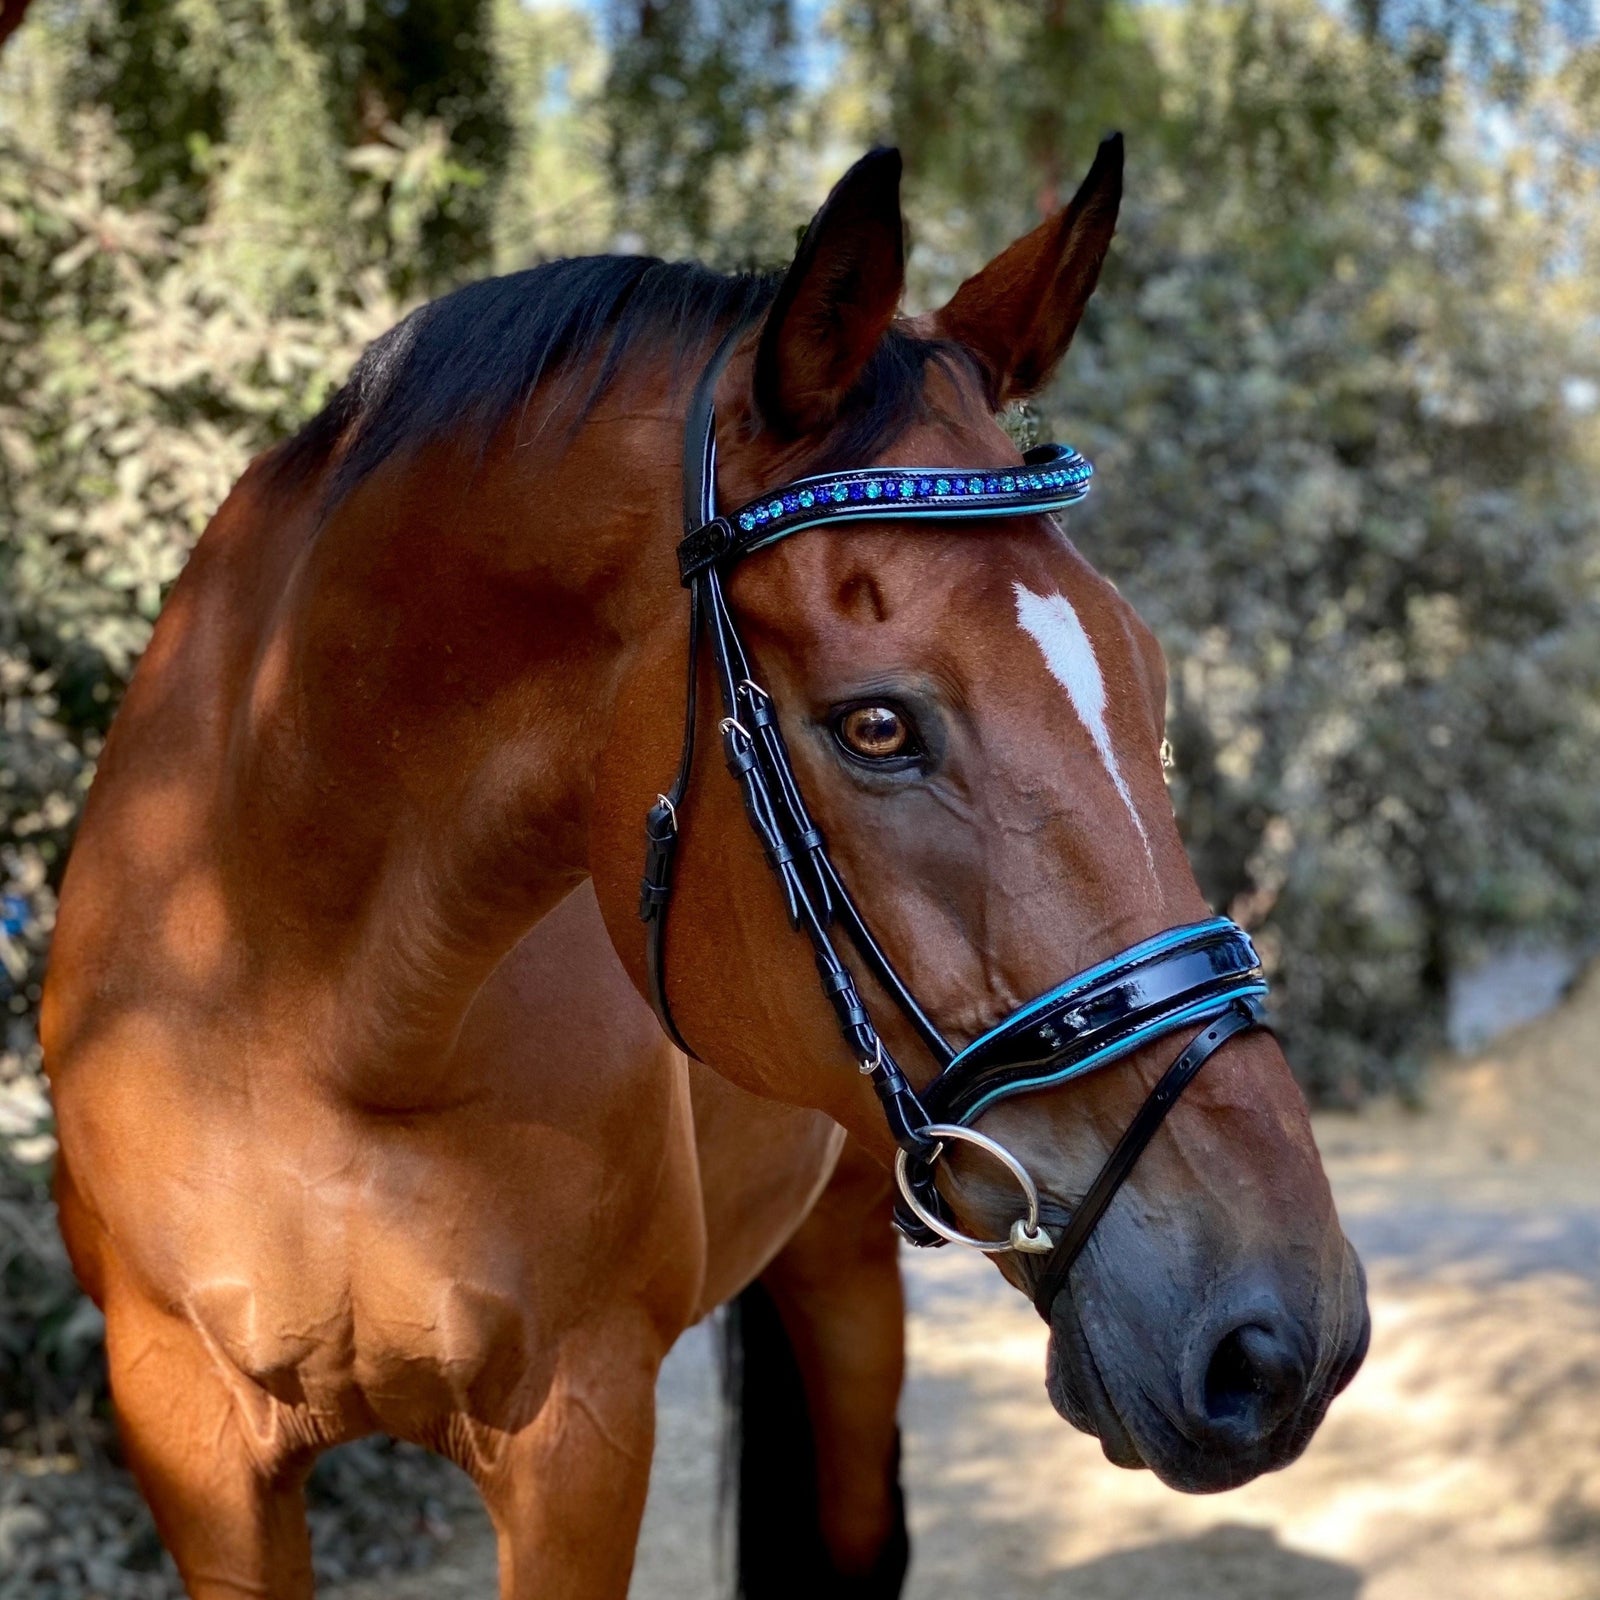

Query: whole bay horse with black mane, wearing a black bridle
[43,141,1366,1600]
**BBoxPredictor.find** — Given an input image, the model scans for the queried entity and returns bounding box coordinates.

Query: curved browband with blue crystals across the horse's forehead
[678,445,1094,582]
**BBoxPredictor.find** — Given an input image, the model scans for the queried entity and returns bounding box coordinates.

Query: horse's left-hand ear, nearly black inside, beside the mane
[755,149,906,437]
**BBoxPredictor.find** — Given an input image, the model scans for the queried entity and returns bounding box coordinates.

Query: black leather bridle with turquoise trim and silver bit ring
[638,330,1267,1322]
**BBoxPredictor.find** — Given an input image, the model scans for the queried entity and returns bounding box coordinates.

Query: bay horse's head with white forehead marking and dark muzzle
[595,139,1368,1491]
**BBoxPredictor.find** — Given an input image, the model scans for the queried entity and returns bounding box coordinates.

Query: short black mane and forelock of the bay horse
[269,256,965,504]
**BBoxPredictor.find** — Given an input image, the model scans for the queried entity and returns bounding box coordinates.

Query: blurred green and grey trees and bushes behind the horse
[0,0,1600,1574]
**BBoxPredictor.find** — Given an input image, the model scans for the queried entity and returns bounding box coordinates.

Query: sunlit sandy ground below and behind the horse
[328,979,1600,1600]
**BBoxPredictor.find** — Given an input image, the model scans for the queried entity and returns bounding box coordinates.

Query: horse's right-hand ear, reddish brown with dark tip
[934,133,1122,411]
